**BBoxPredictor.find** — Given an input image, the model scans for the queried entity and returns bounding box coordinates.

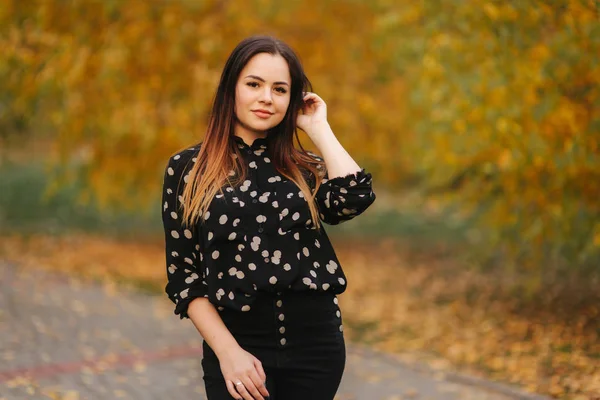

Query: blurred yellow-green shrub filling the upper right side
[377,0,600,271]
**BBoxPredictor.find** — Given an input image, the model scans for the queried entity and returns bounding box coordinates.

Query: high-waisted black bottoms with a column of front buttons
[202,291,346,400]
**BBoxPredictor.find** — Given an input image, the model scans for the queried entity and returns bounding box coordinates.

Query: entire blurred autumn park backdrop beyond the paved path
[0,0,600,399]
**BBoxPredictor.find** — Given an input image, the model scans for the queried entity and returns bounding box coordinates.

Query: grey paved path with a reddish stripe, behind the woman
[0,261,548,400]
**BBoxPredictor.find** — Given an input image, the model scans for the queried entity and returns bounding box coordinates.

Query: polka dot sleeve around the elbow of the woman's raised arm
[311,153,375,225]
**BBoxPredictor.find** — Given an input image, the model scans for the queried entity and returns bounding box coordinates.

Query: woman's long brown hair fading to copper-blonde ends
[182,36,325,229]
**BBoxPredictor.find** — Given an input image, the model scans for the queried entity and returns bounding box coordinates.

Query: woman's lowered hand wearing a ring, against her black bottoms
[219,347,269,400]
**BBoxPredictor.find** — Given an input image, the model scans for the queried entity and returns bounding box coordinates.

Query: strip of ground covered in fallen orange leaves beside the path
[0,235,600,399]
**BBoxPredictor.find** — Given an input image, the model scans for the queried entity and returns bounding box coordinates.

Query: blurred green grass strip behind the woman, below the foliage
[0,162,478,250]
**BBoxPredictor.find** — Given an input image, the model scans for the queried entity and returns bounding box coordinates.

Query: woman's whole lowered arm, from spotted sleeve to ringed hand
[162,153,269,400]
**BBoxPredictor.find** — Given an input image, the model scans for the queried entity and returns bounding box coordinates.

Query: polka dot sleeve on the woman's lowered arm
[162,151,208,319]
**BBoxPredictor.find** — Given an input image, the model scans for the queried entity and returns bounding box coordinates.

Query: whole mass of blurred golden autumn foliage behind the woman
[0,0,600,271]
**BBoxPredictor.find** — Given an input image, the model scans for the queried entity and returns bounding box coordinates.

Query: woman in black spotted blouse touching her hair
[163,36,375,400]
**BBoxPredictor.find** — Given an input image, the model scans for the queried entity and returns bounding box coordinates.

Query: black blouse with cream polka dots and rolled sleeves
[162,136,375,318]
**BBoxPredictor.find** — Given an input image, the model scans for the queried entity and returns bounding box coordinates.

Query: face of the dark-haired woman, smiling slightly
[235,53,292,133]
